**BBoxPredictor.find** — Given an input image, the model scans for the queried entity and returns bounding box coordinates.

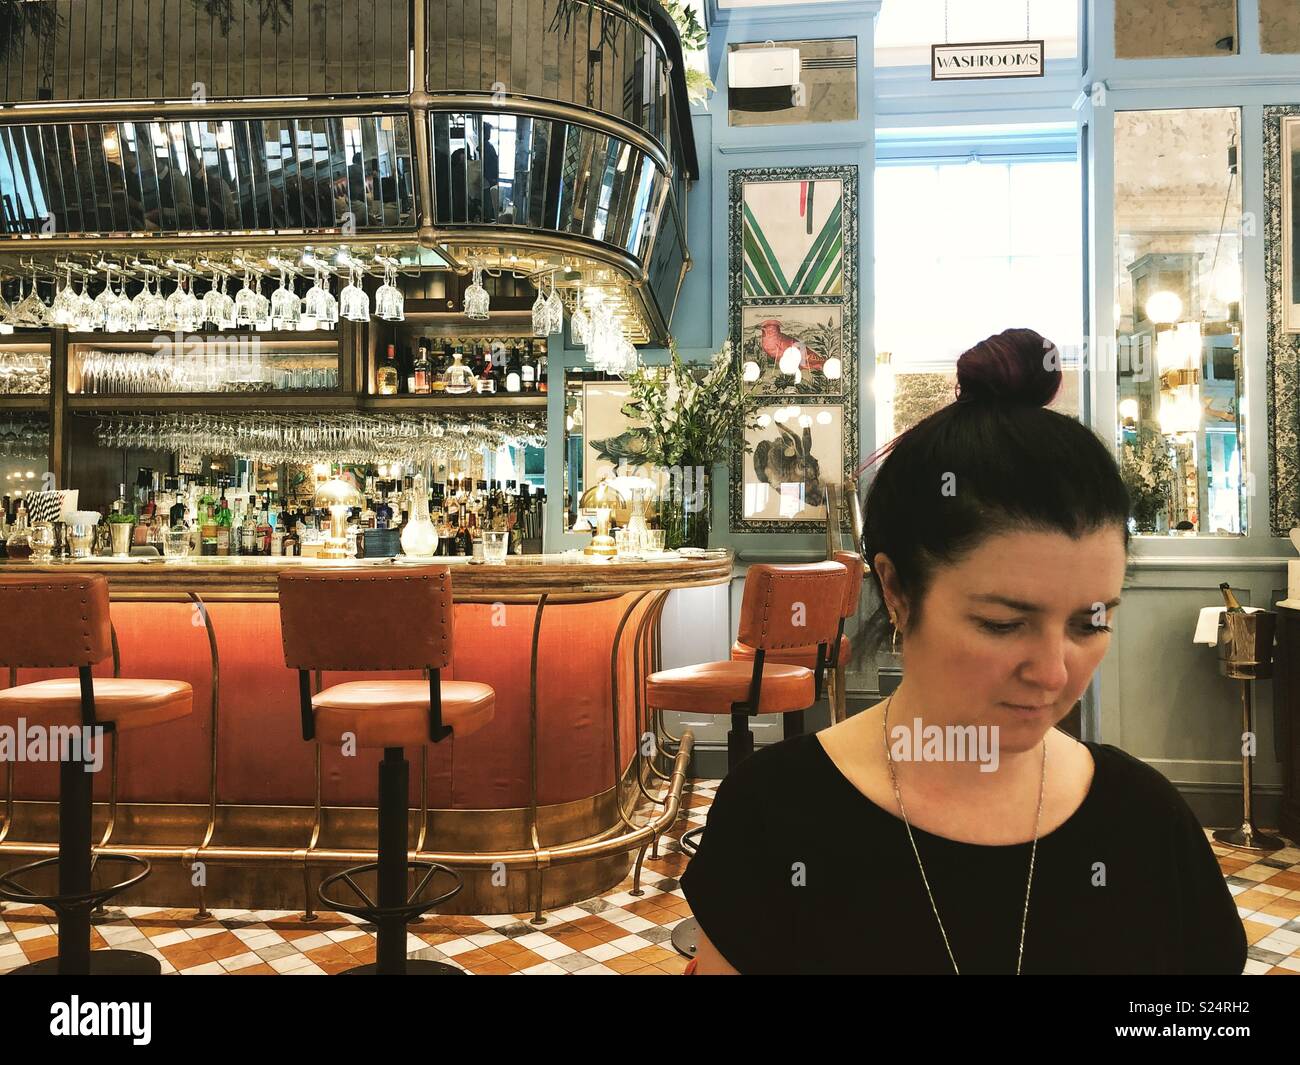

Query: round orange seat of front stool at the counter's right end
[646,662,814,714]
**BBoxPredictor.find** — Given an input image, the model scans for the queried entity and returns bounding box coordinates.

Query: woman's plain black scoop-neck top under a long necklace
[681,735,1245,975]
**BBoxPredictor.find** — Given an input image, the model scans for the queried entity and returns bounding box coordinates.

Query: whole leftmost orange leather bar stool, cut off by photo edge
[0,575,194,975]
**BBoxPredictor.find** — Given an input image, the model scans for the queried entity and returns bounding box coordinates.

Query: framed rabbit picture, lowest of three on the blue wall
[731,399,857,532]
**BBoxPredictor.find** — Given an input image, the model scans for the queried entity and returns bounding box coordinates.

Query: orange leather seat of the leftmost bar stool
[0,676,194,732]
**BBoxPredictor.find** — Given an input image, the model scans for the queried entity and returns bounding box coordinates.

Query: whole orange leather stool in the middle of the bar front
[280,566,497,975]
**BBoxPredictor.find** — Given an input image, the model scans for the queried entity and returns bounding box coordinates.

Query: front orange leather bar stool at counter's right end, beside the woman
[646,560,849,957]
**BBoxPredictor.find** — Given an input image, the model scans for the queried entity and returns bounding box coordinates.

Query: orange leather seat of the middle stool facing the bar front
[312,680,497,748]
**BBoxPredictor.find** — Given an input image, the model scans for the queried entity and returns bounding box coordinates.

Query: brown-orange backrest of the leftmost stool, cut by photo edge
[0,573,113,670]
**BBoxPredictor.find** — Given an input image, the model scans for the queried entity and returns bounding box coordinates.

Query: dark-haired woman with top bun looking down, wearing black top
[681,329,1245,974]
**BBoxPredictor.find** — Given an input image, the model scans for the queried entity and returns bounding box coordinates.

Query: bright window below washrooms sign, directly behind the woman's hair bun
[875,156,1083,446]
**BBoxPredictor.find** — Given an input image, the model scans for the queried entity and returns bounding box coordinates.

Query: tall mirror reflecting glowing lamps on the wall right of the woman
[1115,108,1247,536]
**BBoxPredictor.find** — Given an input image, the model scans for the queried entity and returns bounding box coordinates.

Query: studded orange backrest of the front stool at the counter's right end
[738,560,849,650]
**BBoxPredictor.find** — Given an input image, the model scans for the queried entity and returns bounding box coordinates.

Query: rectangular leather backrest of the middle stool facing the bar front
[280,566,452,671]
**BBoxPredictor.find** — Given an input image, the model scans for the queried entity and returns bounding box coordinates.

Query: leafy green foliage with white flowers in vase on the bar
[623,337,757,467]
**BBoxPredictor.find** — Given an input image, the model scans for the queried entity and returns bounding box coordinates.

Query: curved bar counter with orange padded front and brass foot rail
[0,553,733,917]
